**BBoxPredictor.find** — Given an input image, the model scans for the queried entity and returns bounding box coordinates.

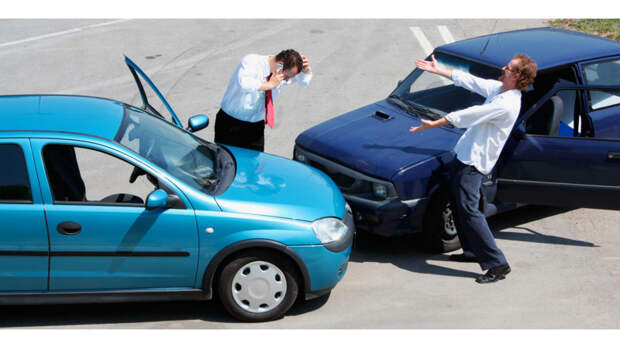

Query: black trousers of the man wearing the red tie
[214,109,265,151]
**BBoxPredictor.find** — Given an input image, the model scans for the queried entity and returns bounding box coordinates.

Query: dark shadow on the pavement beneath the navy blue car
[351,206,597,278]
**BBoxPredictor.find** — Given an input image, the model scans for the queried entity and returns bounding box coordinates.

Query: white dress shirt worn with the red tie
[221,54,312,122]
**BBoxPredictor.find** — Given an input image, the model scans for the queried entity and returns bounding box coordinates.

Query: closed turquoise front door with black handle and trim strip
[32,139,198,291]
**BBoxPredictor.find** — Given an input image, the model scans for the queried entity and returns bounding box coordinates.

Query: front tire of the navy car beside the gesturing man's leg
[422,189,461,253]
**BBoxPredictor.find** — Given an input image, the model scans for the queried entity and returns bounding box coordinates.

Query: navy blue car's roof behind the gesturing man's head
[437,27,620,70]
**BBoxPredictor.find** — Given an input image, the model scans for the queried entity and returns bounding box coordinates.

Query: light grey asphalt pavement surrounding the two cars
[0,19,620,328]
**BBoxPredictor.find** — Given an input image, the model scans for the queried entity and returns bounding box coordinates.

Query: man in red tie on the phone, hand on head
[214,49,312,151]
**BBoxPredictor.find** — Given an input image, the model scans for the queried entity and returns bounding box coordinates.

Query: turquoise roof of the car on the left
[0,95,124,139]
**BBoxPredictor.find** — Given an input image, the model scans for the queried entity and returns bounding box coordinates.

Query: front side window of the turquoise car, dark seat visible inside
[43,144,157,205]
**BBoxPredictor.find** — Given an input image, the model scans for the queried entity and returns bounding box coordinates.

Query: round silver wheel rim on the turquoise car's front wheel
[231,261,287,313]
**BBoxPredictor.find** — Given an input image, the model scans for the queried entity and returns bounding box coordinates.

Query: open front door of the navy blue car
[497,81,620,209]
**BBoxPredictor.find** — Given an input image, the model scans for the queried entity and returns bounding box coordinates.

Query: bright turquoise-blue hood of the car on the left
[215,145,345,221]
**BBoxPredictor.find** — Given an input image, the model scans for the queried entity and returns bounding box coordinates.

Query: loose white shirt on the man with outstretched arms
[445,69,521,175]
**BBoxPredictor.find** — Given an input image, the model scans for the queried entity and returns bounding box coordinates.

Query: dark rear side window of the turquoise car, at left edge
[0,144,32,203]
